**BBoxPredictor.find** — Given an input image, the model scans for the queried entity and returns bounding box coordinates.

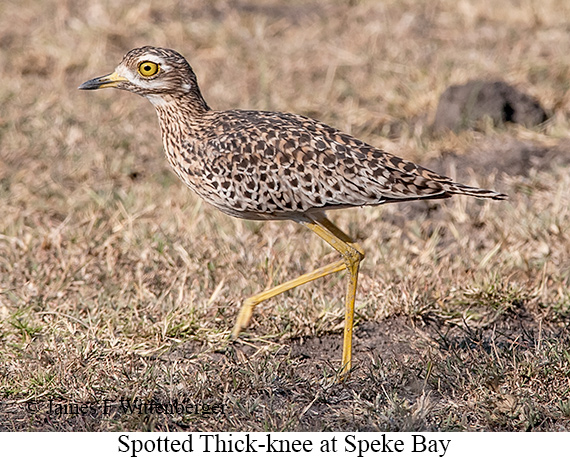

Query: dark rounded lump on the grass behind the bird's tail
[433,80,547,132]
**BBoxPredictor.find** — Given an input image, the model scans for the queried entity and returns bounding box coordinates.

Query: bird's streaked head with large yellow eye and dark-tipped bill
[79,46,203,106]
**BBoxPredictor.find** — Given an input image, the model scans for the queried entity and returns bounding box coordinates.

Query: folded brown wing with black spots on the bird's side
[194,110,488,214]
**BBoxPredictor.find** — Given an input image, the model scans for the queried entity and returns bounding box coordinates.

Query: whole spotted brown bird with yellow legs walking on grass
[79,46,507,379]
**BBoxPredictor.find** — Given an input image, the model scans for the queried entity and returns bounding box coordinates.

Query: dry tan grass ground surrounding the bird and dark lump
[0,0,570,431]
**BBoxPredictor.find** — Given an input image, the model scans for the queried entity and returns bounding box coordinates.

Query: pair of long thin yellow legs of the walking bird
[231,216,364,378]
